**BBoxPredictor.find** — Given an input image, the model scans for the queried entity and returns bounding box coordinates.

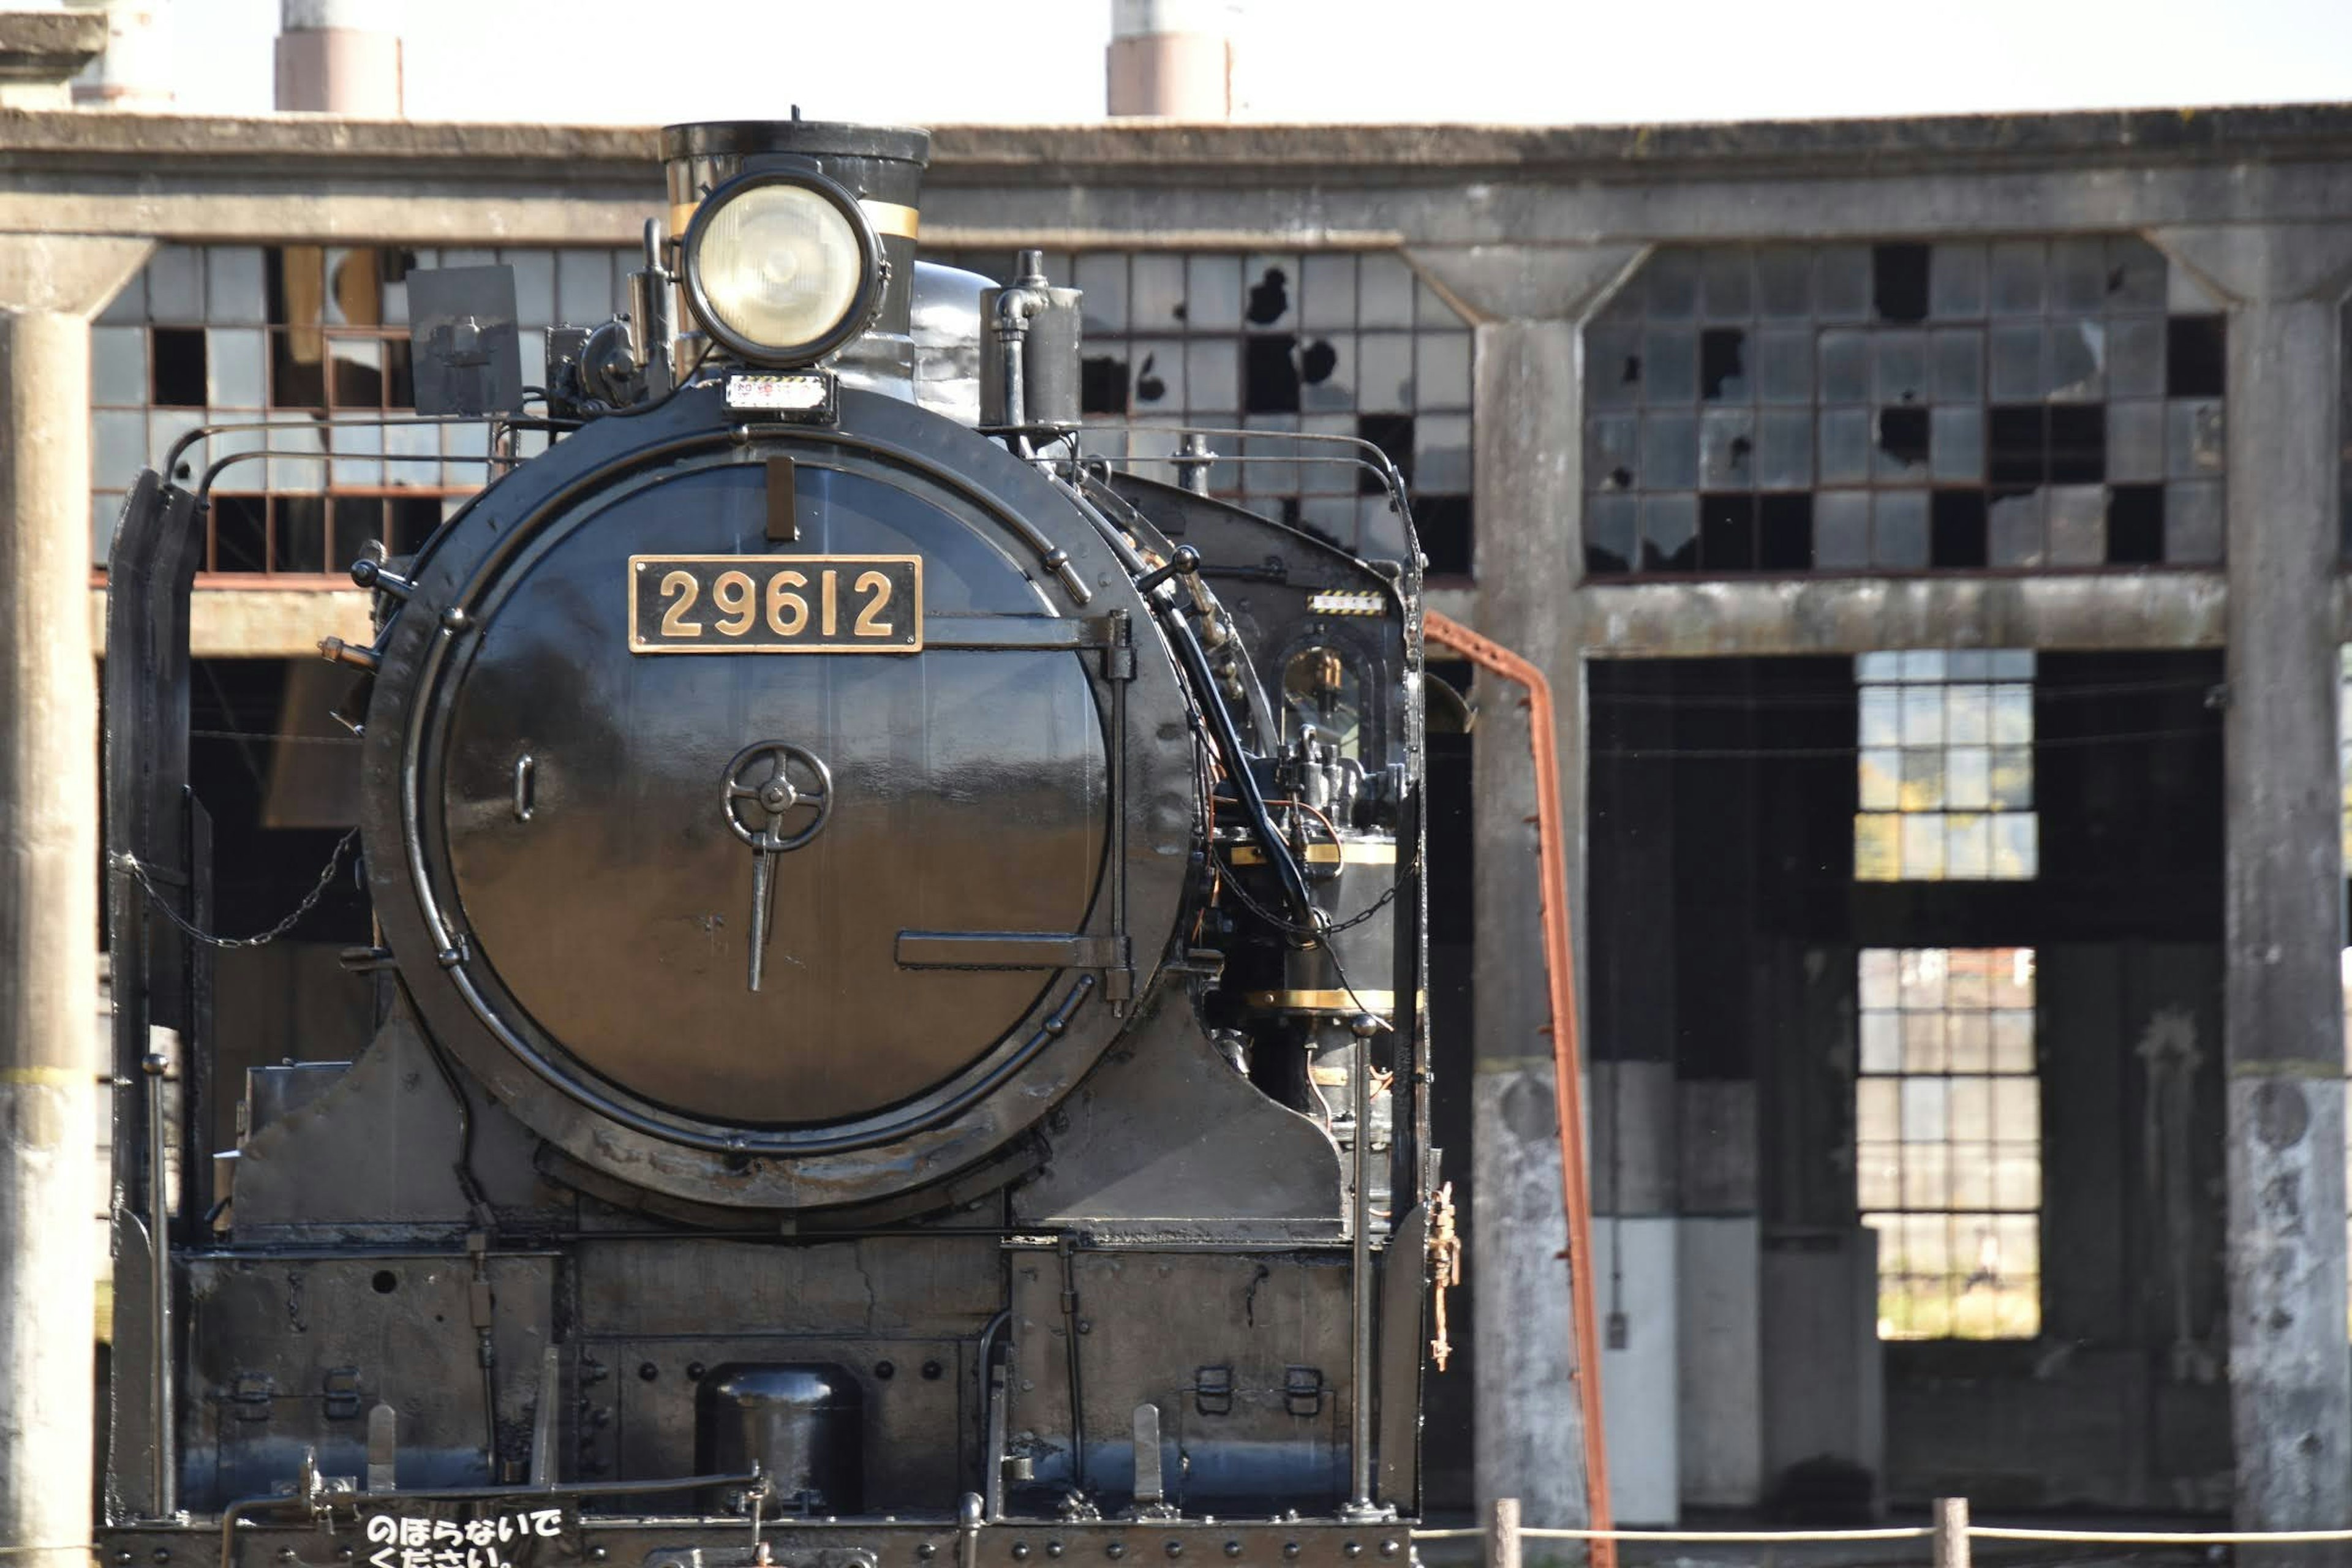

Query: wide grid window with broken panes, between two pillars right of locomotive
[1585,235,2230,578]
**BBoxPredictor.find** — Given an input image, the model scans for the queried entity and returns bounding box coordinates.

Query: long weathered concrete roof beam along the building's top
[0,106,2352,251]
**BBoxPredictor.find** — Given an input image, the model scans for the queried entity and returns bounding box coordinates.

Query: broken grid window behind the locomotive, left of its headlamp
[89,244,635,573]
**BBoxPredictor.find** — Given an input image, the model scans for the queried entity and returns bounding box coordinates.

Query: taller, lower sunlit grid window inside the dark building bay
[1853,948,2041,1340]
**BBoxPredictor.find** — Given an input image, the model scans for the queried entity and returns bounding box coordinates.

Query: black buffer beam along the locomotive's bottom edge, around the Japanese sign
[99,1495,1414,1568]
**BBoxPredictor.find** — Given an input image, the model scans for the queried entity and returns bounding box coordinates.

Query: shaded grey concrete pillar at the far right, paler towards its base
[2157,225,2352,1531]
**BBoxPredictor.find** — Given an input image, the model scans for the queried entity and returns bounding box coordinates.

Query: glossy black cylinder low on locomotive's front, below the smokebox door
[694,1361,865,1514]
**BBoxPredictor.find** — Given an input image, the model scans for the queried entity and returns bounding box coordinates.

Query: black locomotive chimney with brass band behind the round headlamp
[661,120,932,355]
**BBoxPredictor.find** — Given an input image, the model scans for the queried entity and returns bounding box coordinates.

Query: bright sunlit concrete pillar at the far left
[0,235,148,1568]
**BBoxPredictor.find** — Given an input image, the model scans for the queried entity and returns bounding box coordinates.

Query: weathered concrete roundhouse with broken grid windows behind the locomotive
[18,108,2352,1526]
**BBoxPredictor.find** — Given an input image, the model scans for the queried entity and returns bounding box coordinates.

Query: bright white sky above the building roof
[167,0,2352,124]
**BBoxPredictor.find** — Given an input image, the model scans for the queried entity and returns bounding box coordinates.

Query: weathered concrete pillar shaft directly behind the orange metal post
[1470,322,1597,1526]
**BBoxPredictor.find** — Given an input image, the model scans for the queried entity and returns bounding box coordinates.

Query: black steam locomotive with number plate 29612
[101,118,1451,1568]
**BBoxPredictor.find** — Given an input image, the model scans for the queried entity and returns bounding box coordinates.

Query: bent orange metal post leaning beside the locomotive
[1420,609,1616,1568]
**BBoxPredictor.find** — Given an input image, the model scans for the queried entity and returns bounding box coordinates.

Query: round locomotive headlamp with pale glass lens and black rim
[682,169,882,367]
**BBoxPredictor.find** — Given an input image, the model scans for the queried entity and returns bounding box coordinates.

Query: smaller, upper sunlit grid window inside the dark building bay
[1853,649,2041,881]
